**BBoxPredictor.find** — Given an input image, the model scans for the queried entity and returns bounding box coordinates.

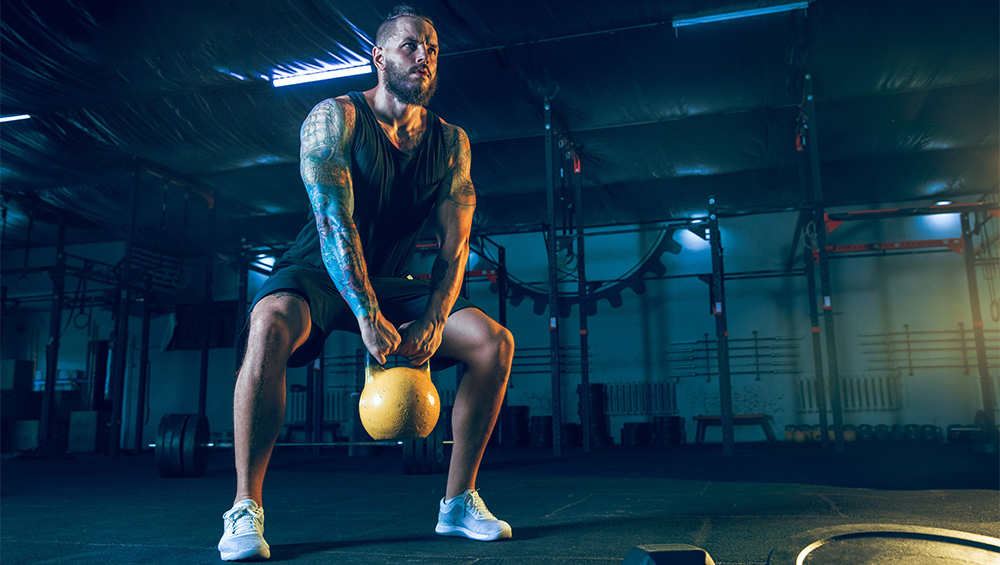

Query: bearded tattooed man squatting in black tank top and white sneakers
[219,6,514,560]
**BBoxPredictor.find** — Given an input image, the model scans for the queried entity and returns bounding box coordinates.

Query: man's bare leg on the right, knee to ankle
[438,308,514,498]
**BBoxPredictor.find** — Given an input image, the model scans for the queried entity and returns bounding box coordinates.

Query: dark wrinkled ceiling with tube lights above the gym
[0,0,1000,256]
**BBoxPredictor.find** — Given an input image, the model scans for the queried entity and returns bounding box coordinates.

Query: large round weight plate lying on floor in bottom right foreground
[767,524,1000,565]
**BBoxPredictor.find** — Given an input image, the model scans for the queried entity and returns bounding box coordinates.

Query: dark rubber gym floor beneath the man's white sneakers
[0,442,1000,565]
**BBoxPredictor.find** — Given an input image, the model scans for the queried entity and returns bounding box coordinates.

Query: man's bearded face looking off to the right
[382,17,438,106]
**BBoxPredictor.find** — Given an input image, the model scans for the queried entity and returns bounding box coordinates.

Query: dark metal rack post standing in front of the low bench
[708,196,734,455]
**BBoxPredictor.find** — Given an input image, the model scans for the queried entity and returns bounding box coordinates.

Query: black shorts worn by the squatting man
[241,265,478,369]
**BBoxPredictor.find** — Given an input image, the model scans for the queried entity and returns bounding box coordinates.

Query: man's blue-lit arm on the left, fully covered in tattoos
[299,97,399,363]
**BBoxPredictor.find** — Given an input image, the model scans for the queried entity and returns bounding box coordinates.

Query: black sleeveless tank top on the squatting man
[274,92,448,277]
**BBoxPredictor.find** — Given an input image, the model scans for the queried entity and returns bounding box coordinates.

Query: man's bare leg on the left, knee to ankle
[233,292,312,505]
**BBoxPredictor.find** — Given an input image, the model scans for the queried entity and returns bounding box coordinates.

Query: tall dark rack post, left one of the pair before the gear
[545,97,562,457]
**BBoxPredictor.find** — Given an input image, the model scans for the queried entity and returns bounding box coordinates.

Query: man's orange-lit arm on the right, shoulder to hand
[399,119,476,365]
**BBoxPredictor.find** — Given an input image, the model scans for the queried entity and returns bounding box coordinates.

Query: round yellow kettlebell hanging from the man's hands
[358,354,441,440]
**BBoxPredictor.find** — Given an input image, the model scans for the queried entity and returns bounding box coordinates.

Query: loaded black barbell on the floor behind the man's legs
[149,414,453,478]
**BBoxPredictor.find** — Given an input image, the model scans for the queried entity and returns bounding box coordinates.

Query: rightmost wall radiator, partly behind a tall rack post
[796,374,903,412]
